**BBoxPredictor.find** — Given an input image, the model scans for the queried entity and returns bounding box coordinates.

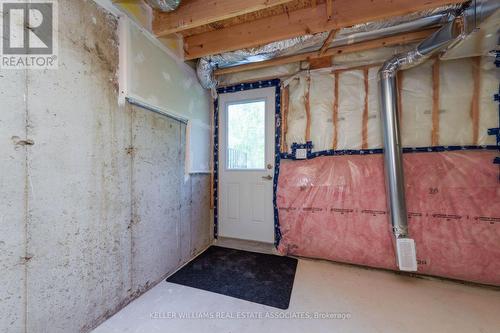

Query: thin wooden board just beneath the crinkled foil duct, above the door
[215,29,436,75]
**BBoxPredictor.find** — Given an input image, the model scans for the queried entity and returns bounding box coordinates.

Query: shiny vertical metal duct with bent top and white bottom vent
[379,1,498,270]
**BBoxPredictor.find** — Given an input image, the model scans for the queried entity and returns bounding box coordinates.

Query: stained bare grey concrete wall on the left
[0,0,211,333]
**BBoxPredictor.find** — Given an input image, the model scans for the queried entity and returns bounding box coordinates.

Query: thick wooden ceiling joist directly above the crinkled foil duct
[184,0,462,60]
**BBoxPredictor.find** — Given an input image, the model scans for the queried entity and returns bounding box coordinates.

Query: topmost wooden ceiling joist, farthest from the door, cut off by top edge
[153,0,292,37]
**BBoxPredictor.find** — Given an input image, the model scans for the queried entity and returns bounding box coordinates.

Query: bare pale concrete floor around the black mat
[93,255,500,333]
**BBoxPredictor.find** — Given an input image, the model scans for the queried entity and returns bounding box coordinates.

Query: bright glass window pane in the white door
[226,101,266,170]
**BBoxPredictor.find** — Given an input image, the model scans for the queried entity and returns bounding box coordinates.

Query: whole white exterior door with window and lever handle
[218,87,276,243]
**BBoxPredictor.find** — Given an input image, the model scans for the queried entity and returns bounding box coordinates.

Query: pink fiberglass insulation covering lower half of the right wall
[278,151,500,285]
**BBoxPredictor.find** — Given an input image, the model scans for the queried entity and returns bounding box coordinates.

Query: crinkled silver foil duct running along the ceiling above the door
[197,5,461,89]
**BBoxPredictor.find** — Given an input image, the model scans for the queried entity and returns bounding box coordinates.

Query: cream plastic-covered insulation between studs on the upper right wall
[286,57,499,151]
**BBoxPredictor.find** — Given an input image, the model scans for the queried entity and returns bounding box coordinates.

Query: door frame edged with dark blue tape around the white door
[213,79,281,246]
